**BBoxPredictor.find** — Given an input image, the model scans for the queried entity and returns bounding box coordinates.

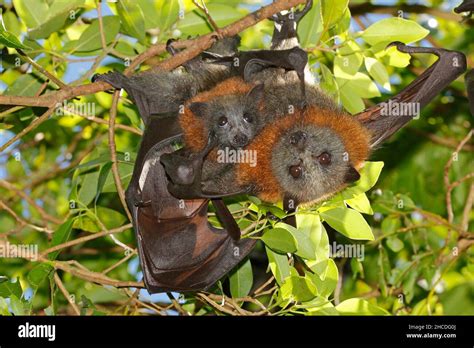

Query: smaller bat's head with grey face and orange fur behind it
[180,78,264,152]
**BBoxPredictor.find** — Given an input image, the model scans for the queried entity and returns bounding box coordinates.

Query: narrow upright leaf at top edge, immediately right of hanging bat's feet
[298,0,323,47]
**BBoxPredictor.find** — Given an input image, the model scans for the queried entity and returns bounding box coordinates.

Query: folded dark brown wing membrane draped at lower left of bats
[127,118,256,293]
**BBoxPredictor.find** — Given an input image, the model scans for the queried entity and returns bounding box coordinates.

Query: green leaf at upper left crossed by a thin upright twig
[63,16,120,54]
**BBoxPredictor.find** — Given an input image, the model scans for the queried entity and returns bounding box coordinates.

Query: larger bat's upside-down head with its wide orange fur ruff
[237,107,370,204]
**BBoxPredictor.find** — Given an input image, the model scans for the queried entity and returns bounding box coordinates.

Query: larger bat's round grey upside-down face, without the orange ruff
[271,125,359,203]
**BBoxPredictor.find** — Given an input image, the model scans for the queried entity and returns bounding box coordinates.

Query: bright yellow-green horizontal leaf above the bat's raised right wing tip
[361,17,429,45]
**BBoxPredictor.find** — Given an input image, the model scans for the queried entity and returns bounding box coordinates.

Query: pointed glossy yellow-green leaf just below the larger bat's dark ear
[320,208,374,240]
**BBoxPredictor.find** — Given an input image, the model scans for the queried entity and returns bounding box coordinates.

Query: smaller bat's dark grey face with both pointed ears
[189,85,263,149]
